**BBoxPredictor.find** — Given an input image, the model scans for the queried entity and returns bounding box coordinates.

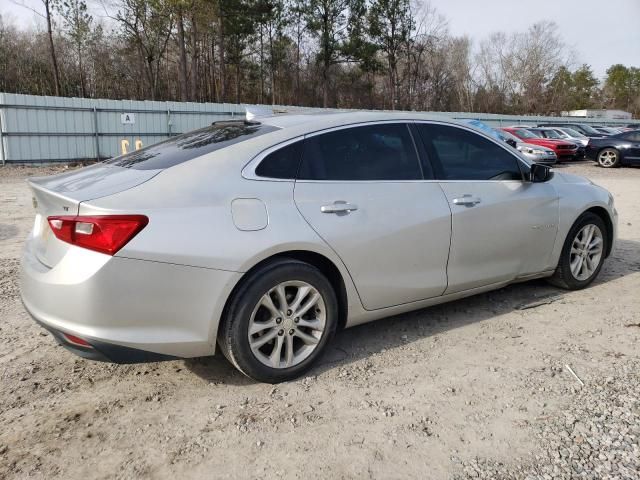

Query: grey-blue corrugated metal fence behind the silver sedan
[0,93,640,164]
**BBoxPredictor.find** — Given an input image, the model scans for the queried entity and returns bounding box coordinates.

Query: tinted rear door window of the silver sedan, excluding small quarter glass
[298,123,422,181]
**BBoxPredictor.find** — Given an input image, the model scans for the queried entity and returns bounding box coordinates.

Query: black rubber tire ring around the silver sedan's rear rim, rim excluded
[223,260,338,383]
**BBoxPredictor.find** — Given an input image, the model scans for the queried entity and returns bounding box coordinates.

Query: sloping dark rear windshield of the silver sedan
[105,121,278,170]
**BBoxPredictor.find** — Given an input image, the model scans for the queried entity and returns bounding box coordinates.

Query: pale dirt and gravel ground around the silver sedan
[0,162,640,479]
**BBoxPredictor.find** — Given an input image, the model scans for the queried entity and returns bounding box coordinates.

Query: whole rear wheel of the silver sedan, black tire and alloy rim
[218,259,338,383]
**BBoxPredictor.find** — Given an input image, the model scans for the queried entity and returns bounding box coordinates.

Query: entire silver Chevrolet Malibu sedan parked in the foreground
[21,113,617,382]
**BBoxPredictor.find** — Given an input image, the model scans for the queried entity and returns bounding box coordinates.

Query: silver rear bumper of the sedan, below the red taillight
[21,236,240,363]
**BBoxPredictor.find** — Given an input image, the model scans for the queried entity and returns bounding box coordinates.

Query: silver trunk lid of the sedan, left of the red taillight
[27,164,161,268]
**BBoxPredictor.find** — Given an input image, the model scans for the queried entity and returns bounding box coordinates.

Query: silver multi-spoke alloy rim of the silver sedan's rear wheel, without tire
[248,280,327,368]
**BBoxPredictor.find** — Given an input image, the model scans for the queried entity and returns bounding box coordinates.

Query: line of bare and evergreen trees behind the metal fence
[0,0,640,116]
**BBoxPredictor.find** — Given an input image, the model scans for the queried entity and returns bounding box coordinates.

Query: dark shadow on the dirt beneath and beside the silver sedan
[185,240,640,385]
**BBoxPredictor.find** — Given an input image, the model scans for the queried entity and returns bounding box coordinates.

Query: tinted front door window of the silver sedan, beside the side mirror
[418,124,522,180]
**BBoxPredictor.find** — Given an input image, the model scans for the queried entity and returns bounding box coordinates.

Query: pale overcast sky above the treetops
[0,0,640,78]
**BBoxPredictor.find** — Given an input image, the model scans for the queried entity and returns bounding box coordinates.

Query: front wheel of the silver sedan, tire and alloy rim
[548,212,609,290]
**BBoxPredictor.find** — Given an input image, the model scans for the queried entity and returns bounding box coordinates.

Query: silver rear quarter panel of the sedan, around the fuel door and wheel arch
[79,150,363,339]
